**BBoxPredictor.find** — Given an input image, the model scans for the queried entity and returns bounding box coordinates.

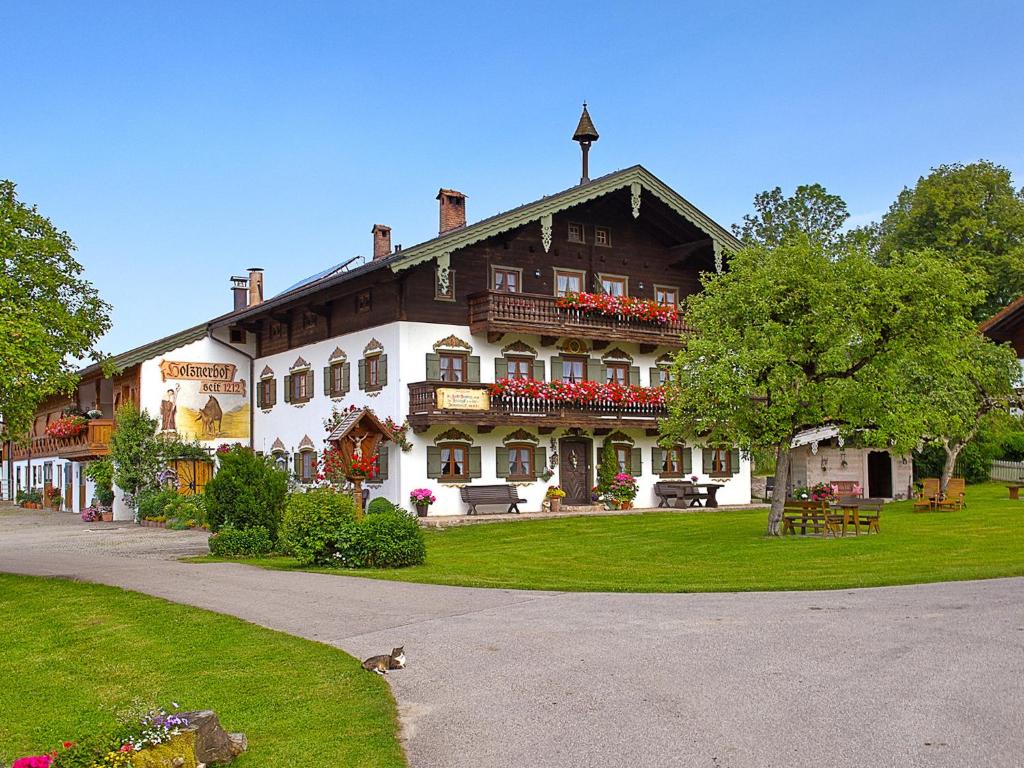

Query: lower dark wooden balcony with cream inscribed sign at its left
[409,381,668,434]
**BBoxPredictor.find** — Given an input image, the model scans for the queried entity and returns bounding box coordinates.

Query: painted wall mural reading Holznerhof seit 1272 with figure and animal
[160,360,249,440]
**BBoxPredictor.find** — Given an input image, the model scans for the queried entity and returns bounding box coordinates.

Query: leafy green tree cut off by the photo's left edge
[0,180,111,438]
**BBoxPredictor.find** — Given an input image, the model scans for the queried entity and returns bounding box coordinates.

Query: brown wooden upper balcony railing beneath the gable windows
[469,291,690,348]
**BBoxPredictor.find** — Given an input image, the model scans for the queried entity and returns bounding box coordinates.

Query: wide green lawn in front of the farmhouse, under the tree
[190,483,1024,592]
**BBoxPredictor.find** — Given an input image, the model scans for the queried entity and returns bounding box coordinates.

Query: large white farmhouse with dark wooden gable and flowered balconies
[8,109,751,514]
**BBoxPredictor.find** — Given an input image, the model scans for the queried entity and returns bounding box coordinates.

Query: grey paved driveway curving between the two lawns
[0,513,1024,768]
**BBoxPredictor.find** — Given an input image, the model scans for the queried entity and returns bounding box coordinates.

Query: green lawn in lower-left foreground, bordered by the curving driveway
[0,574,406,768]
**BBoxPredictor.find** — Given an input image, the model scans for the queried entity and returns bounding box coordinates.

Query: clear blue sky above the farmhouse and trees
[0,0,1024,352]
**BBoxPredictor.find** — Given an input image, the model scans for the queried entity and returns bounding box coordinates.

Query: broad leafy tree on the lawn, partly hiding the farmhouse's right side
[664,239,971,536]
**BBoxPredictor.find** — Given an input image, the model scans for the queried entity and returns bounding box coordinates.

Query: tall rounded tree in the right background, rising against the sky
[879,161,1024,321]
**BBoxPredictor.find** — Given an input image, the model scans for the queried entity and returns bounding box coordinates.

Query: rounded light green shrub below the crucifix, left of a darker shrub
[281,488,355,565]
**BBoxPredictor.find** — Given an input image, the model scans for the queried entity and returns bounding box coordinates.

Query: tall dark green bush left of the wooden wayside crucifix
[204,445,288,541]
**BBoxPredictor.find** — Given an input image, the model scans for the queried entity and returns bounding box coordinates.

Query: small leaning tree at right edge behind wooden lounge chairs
[903,332,1022,493]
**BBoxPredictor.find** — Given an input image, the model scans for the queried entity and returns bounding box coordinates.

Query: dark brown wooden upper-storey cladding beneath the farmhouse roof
[238,182,715,356]
